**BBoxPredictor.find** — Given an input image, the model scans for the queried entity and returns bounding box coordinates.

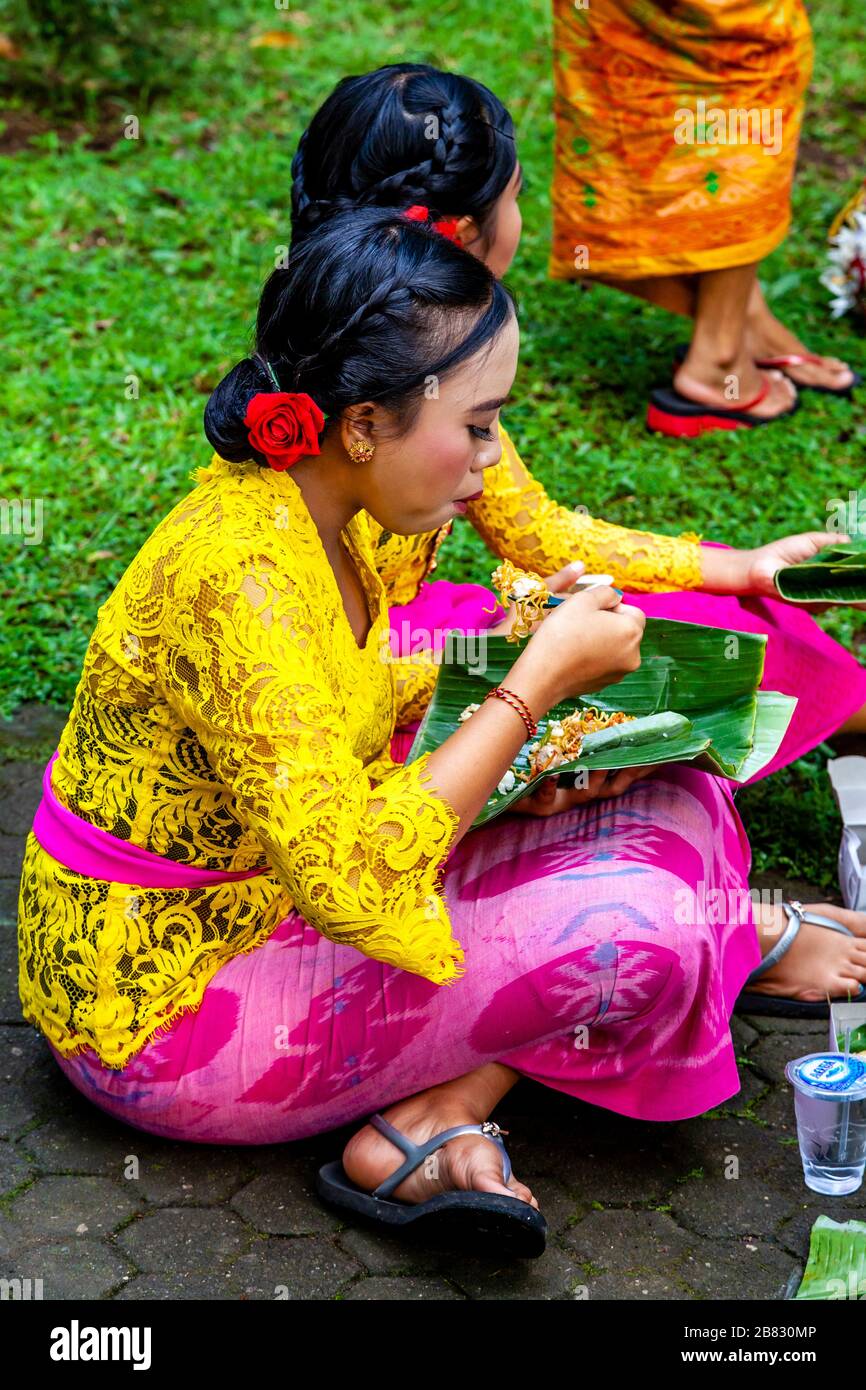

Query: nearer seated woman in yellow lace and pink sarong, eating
[19,209,866,1254]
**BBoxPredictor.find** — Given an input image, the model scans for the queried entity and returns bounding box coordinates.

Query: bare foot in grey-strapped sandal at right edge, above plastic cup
[748,902,866,1002]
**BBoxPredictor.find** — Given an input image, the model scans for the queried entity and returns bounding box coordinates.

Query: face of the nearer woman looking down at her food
[357,313,520,535]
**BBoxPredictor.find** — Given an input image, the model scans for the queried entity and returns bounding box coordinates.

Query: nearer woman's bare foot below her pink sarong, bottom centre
[343,1073,538,1209]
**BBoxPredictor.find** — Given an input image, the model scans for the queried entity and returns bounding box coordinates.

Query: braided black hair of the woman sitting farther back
[292,63,517,238]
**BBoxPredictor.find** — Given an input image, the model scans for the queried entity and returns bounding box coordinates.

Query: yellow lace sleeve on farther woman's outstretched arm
[467,427,702,594]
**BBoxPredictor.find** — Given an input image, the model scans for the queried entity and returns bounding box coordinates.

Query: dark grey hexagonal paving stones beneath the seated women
[0,706,866,1301]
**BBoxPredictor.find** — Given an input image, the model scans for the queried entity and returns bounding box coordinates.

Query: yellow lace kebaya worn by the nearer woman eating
[18,457,464,1068]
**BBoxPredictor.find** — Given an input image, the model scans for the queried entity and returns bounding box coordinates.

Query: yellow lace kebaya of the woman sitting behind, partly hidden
[370,425,702,603]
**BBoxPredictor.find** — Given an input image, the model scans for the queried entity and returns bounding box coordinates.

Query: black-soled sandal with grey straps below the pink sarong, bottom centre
[316,1115,548,1259]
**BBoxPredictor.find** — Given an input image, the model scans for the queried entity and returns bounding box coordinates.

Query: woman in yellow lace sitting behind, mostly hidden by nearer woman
[292,63,866,776]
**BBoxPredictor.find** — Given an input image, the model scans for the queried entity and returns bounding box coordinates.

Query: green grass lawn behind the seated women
[0,0,866,884]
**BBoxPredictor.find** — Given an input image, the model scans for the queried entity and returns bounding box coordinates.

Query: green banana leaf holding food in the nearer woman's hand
[407,617,796,826]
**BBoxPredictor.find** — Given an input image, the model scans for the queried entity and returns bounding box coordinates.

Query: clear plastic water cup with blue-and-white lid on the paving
[785,1052,866,1197]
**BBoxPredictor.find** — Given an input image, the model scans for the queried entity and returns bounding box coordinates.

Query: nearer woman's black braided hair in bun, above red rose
[204,207,513,464]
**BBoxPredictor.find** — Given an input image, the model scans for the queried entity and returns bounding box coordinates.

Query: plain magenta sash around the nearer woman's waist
[33,753,267,888]
